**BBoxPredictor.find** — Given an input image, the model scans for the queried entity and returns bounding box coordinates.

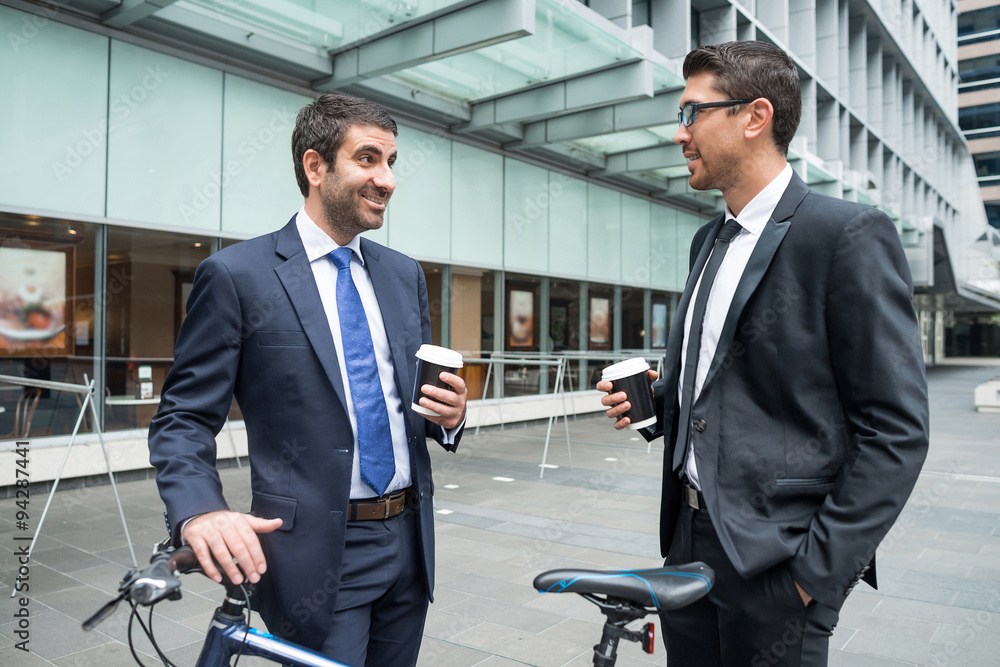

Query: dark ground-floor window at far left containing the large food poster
[0,213,99,441]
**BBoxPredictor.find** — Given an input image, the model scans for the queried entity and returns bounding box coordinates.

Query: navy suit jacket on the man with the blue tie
[149,217,457,648]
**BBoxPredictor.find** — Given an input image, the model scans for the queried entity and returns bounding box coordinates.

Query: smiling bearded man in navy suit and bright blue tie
[149,94,466,666]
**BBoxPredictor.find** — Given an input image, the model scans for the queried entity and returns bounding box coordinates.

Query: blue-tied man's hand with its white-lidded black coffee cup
[411,345,467,428]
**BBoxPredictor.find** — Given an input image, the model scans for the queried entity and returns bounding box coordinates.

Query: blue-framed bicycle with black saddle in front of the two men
[83,544,715,667]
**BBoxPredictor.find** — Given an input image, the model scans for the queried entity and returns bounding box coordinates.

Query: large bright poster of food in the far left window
[0,247,75,357]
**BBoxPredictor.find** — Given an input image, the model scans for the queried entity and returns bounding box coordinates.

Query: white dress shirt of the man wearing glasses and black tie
[677,164,792,489]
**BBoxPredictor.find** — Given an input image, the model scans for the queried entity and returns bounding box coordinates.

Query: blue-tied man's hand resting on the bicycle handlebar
[181,510,281,584]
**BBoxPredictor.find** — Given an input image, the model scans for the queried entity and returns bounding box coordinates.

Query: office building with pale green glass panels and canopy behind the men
[0,0,1000,486]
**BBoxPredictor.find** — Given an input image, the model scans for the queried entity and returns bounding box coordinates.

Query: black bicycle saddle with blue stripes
[534,563,715,611]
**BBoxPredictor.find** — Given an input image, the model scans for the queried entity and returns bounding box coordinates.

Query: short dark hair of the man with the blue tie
[292,93,399,197]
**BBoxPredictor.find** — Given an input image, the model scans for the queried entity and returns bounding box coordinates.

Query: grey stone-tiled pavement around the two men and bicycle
[0,365,1000,667]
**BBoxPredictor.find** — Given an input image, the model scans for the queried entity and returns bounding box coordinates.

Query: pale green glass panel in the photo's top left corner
[0,7,109,216]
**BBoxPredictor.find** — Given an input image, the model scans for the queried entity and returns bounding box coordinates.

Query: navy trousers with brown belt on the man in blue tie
[322,507,428,667]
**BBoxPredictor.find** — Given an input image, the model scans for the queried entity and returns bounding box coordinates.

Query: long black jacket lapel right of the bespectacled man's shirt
[702,172,809,391]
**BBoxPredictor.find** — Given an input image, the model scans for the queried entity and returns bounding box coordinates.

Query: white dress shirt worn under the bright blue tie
[295,207,461,500]
